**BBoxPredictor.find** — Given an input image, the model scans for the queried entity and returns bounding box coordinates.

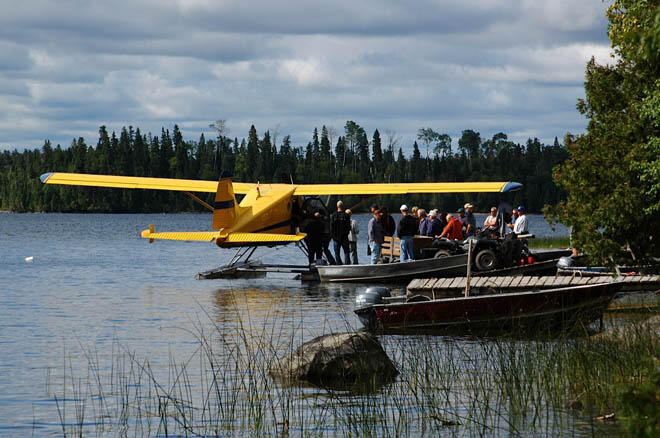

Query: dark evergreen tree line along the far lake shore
[0,120,567,212]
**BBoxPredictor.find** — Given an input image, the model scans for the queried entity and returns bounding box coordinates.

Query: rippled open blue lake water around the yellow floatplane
[0,214,620,436]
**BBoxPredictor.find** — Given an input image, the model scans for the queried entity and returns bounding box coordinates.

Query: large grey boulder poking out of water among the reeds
[270,332,399,389]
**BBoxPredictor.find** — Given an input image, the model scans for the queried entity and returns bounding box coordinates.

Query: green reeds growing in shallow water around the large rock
[47,306,660,436]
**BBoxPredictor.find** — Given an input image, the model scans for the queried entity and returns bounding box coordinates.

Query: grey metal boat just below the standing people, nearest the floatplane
[316,254,468,284]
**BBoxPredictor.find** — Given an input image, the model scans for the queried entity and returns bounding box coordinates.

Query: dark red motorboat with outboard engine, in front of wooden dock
[355,282,621,334]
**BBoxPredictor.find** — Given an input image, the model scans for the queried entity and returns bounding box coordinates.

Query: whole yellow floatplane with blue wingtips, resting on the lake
[41,172,522,276]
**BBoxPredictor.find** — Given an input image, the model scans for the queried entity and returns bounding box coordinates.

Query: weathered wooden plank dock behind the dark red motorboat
[407,275,660,298]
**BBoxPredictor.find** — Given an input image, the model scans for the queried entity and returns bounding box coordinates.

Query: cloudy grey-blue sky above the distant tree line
[0,0,612,155]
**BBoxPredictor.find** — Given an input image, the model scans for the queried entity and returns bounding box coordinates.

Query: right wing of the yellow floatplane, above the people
[293,182,522,196]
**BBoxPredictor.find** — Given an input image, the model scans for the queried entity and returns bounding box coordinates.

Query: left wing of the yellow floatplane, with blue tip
[41,172,255,195]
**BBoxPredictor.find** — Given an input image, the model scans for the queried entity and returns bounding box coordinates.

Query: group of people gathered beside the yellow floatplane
[303,201,528,265]
